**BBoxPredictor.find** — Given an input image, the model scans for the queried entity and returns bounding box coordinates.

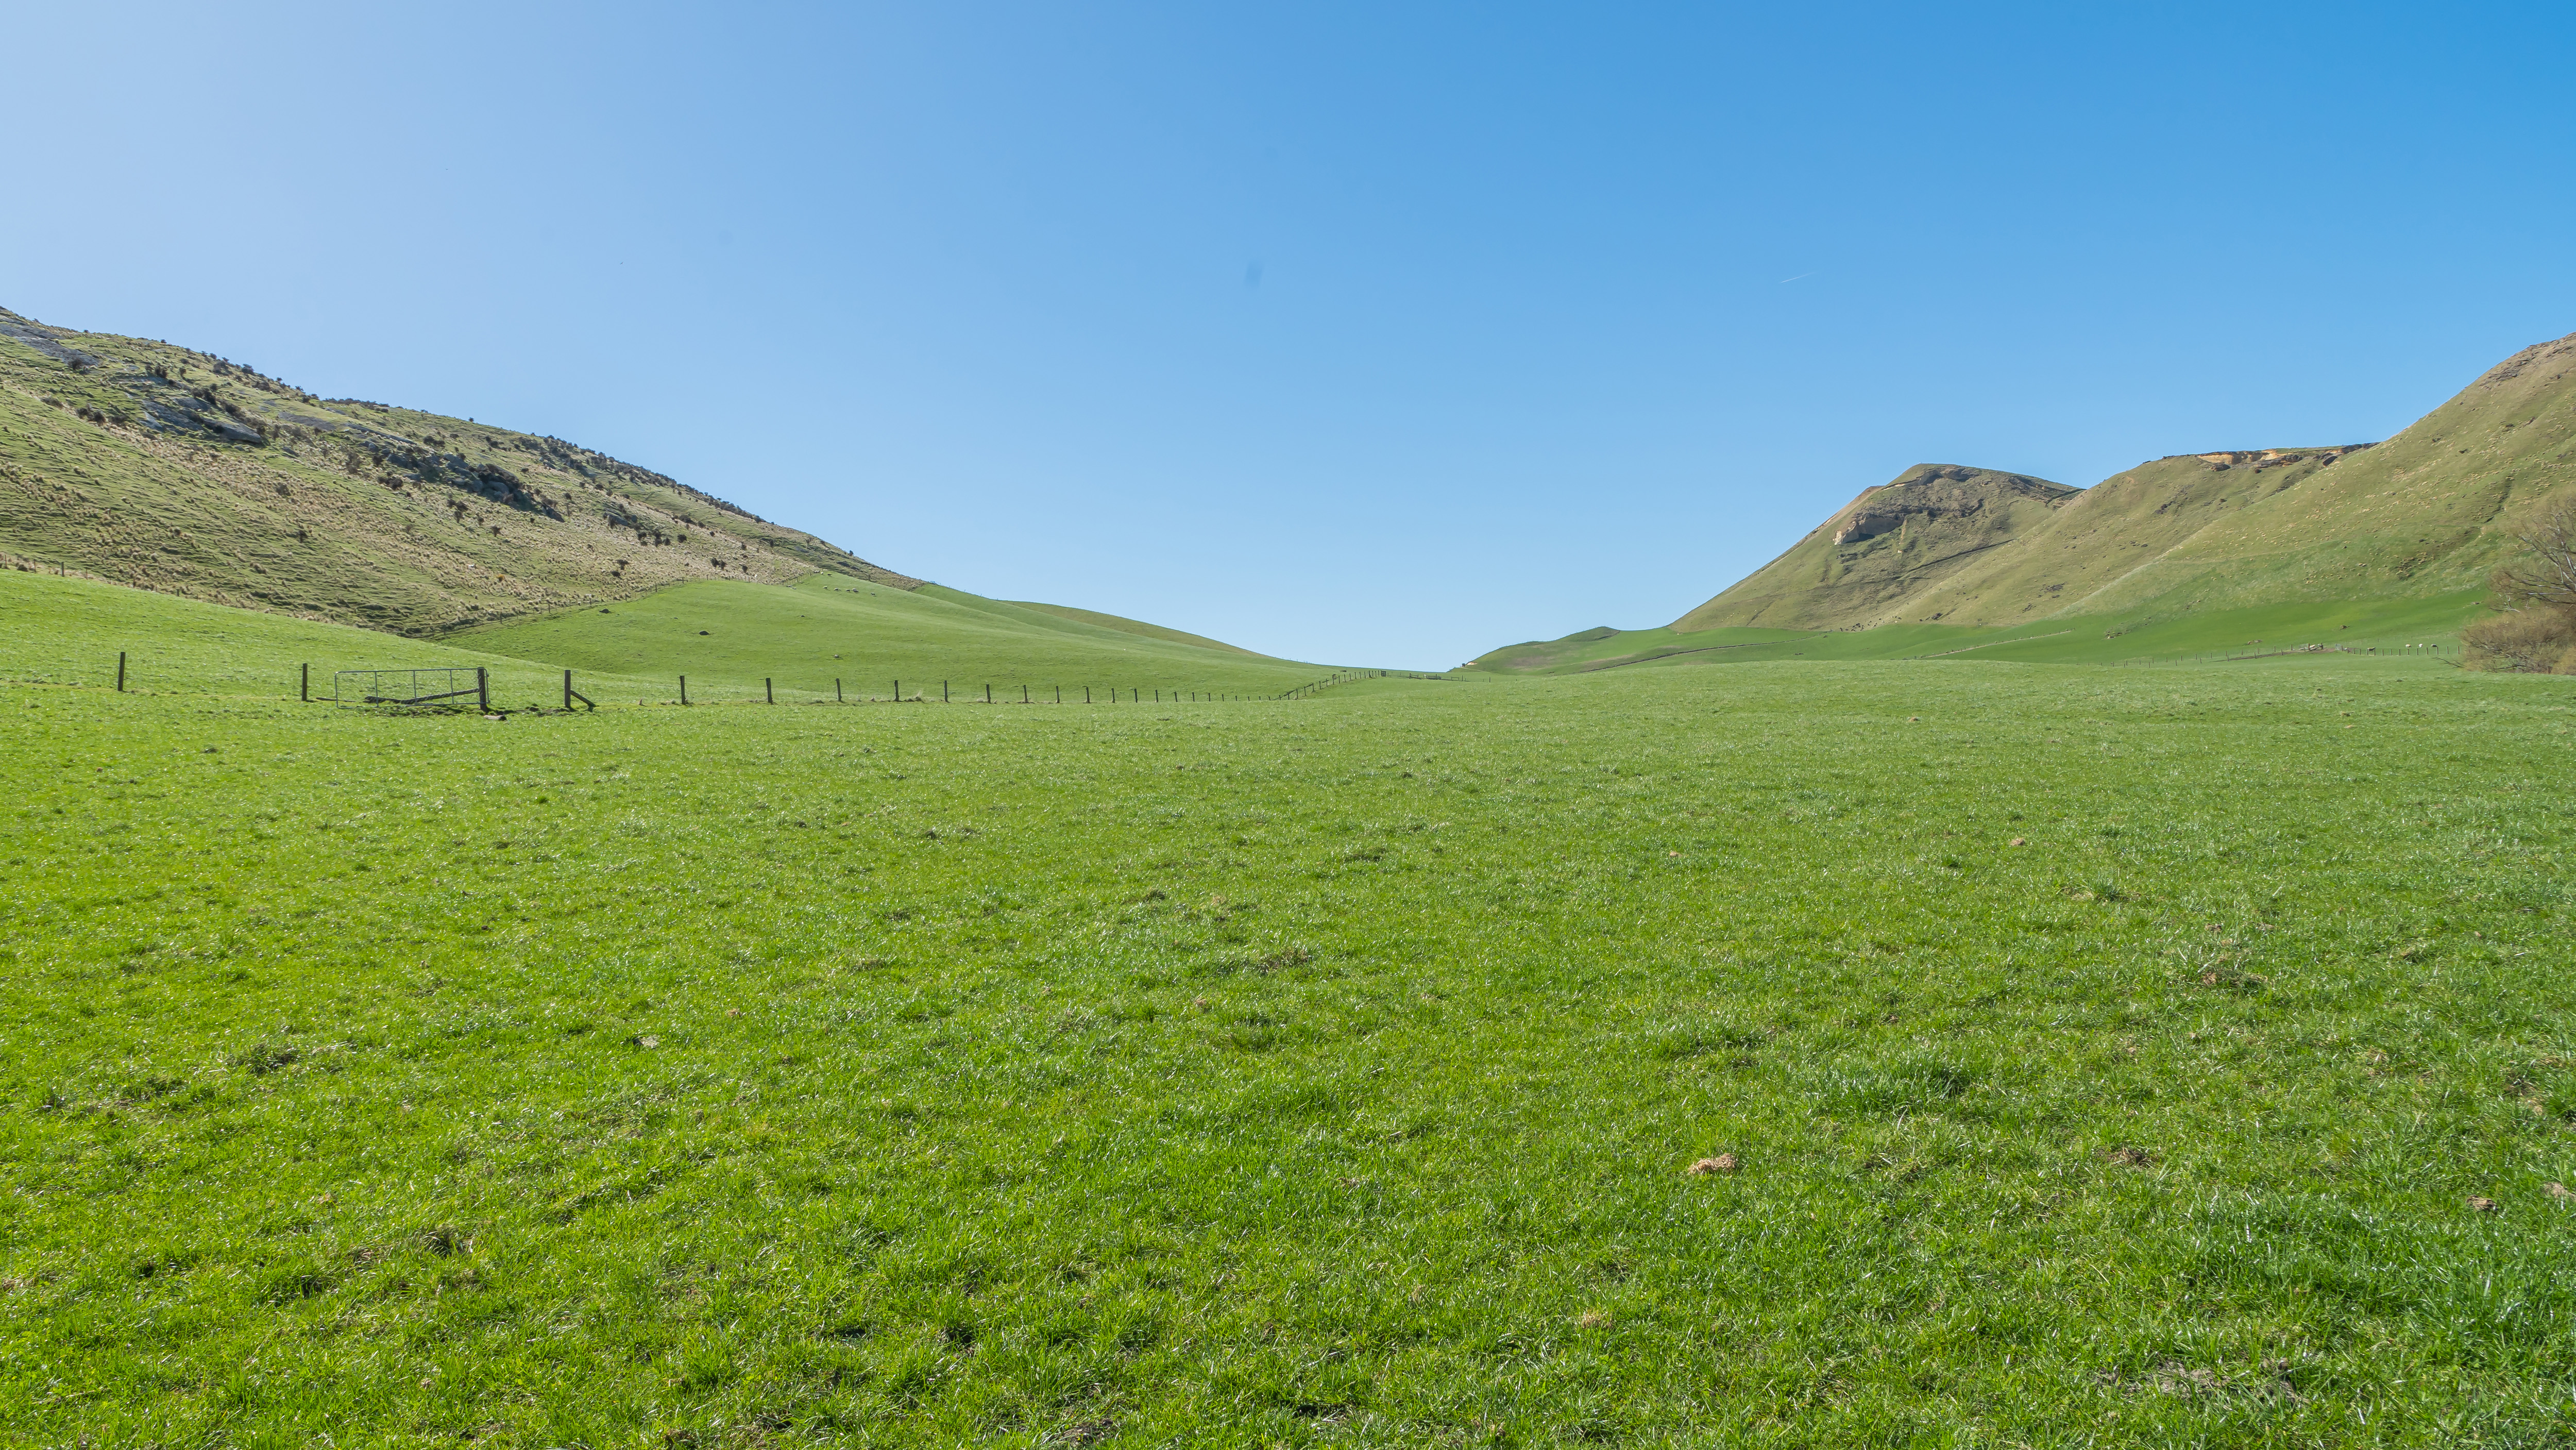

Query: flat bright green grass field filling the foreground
[0,575,2576,1447]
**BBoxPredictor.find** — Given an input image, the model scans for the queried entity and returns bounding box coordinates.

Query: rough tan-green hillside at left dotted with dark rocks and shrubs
[0,312,914,634]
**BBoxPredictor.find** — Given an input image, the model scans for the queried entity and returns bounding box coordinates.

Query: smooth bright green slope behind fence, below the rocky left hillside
[453,572,1319,698]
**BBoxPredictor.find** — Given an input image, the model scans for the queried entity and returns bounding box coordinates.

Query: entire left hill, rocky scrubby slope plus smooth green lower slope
[0,309,1288,690]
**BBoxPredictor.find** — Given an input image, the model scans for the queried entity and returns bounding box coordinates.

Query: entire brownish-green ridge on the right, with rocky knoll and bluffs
[1649,335,2576,641]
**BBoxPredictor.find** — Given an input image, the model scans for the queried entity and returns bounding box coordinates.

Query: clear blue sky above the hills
[0,0,2576,667]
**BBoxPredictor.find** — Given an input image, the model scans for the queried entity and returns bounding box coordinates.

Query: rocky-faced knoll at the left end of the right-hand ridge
[1672,464,2076,631]
